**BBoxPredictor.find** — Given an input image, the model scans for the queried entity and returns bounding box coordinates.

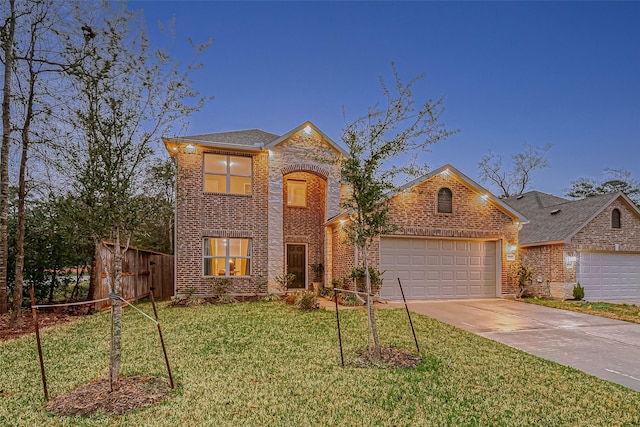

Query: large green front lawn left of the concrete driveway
[0,303,640,426]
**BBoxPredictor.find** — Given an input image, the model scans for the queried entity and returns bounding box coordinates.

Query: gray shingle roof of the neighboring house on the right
[504,191,640,246]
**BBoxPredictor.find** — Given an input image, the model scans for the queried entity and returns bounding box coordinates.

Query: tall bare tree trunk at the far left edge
[0,0,16,314]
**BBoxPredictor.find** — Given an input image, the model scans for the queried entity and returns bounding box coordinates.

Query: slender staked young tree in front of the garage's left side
[341,64,456,358]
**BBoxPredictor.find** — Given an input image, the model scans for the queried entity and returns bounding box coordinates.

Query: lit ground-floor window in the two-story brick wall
[203,237,251,276]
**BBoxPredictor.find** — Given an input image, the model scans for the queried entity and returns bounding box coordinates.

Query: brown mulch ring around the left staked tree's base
[46,376,171,416]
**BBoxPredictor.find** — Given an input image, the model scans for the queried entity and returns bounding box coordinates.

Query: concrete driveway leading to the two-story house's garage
[391,299,640,391]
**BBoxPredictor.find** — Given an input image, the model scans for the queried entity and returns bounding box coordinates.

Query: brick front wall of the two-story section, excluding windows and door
[172,125,340,296]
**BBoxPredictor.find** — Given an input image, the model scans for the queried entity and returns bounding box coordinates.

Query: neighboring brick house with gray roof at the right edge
[505,191,640,300]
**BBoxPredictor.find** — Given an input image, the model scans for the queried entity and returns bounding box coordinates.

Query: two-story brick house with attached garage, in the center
[164,122,526,298]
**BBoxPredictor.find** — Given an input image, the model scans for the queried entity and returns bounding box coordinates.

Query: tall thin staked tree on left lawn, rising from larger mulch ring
[58,2,209,390]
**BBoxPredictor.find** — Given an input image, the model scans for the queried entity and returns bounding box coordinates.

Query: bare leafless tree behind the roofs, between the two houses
[478,144,551,198]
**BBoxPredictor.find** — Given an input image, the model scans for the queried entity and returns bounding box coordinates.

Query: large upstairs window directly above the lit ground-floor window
[203,153,252,194]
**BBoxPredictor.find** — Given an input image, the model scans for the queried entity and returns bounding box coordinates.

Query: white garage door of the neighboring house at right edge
[578,253,640,301]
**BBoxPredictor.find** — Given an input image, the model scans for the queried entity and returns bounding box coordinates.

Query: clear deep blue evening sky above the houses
[129,1,640,195]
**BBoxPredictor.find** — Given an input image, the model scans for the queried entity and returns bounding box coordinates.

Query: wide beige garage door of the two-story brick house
[380,237,496,299]
